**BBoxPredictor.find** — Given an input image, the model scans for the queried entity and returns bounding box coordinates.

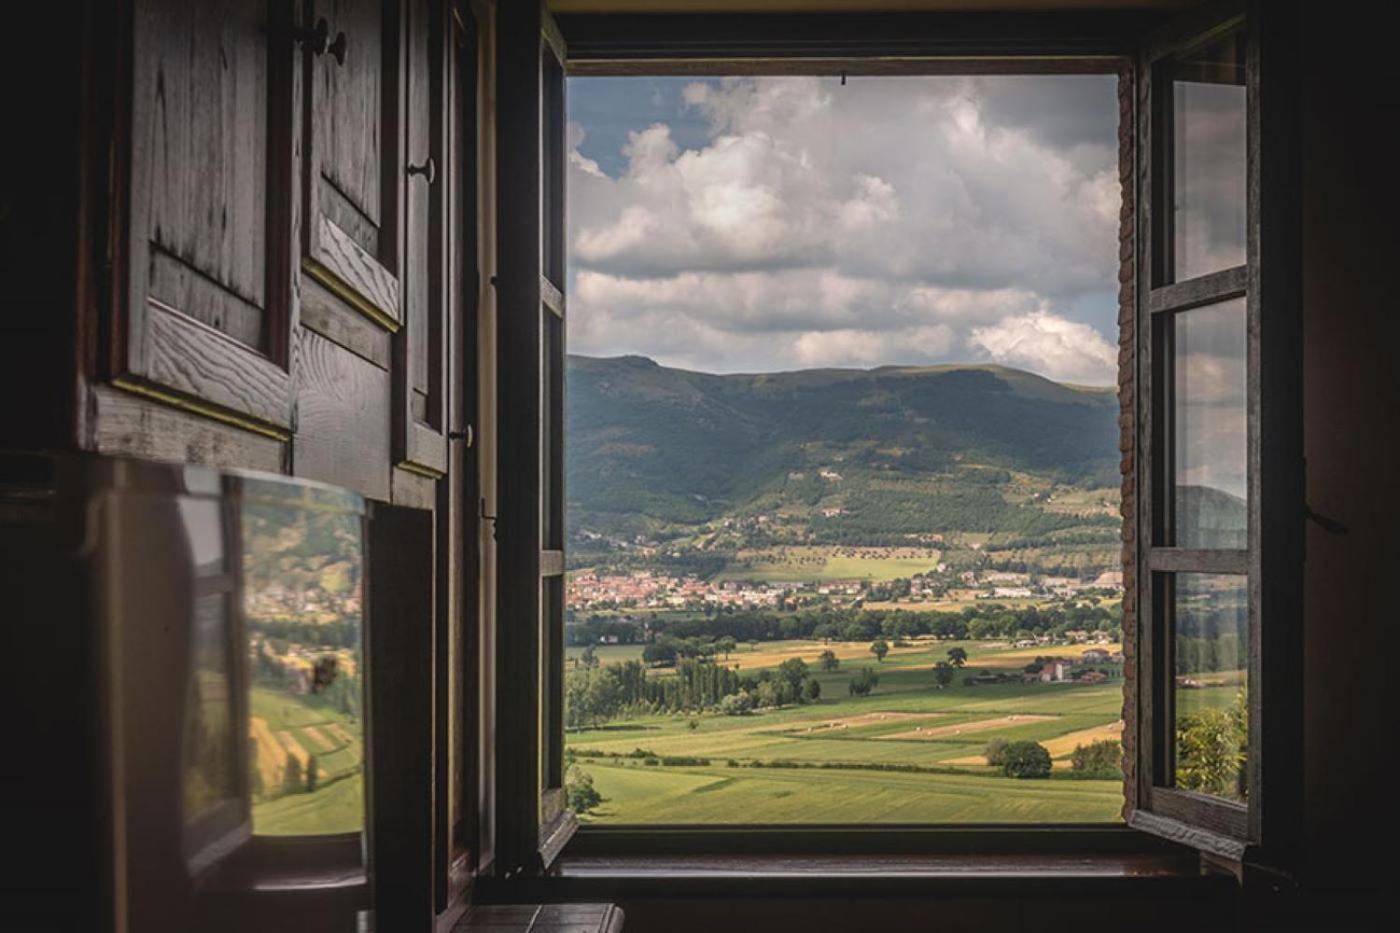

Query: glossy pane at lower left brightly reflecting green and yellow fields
[242,482,364,835]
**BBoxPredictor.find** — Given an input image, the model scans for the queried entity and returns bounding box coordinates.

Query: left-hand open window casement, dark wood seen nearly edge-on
[496,3,577,873]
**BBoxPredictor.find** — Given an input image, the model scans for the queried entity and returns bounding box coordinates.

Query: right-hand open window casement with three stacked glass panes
[1130,3,1303,866]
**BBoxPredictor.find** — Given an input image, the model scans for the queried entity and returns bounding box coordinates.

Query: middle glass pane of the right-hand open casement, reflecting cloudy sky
[1172,298,1249,548]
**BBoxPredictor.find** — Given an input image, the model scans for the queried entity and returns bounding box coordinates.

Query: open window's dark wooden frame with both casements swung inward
[496,4,1302,876]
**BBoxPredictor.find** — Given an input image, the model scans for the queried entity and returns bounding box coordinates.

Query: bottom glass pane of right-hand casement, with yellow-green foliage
[1175,573,1249,800]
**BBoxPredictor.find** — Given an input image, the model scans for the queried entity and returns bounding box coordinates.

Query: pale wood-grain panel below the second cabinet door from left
[293,329,391,500]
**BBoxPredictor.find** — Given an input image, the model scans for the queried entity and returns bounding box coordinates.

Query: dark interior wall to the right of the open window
[1302,1,1400,906]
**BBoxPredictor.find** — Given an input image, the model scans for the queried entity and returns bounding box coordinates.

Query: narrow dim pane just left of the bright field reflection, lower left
[182,591,238,822]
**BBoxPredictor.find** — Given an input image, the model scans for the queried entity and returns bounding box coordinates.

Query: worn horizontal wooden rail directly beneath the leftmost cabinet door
[92,385,287,474]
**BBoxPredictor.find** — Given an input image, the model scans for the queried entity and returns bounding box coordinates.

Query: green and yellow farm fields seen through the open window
[567,639,1123,824]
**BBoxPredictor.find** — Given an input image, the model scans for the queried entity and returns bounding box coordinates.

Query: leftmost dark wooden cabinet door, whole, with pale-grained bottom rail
[117,0,294,440]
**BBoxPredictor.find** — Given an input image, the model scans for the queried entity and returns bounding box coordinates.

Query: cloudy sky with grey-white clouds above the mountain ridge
[568,76,1119,385]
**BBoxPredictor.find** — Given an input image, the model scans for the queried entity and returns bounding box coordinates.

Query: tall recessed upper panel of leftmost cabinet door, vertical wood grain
[132,0,267,310]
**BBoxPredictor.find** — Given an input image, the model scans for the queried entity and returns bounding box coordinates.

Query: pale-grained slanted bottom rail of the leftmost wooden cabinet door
[137,301,291,427]
